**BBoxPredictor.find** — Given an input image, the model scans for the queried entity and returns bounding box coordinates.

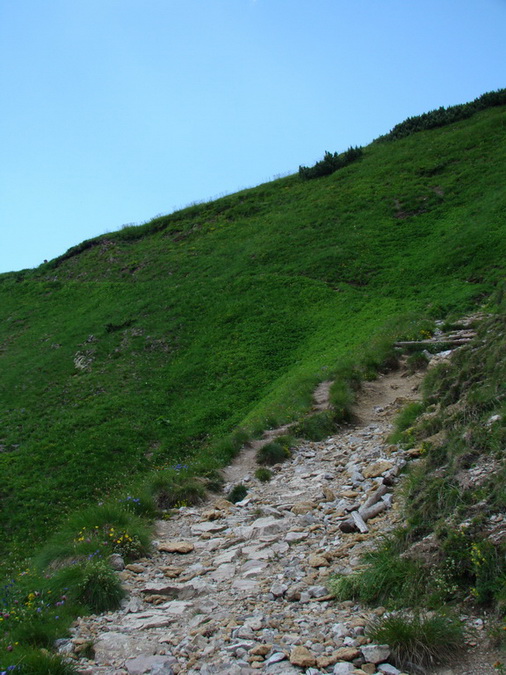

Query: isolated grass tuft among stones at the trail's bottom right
[368,611,465,672]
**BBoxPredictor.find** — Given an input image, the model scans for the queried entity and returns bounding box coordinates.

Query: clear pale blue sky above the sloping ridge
[0,0,506,272]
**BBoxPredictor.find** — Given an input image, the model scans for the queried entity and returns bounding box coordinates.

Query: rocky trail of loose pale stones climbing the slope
[67,328,502,675]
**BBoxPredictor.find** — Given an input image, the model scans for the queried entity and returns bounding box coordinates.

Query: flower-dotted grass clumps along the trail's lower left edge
[0,497,151,675]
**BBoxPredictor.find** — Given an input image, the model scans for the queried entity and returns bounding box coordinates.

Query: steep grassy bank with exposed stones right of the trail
[333,302,506,615]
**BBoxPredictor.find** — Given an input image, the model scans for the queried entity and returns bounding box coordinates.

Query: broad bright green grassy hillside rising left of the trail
[0,97,506,572]
